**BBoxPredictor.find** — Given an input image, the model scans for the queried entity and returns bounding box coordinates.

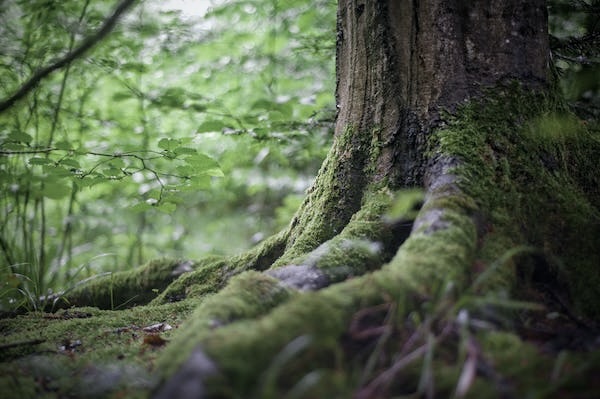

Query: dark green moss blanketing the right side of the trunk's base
[430,86,600,317]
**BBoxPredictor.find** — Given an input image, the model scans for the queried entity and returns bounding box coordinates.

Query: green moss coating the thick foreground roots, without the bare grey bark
[156,181,476,397]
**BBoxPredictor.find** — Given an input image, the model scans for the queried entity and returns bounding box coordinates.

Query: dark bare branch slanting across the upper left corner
[0,0,136,112]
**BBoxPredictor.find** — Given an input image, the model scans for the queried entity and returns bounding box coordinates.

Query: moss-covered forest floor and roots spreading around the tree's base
[0,85,600,399]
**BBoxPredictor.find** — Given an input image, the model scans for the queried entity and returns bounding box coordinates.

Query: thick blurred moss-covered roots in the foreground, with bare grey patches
[155,158,488,398]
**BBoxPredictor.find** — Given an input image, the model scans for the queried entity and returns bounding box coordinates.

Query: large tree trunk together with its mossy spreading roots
[1,0,600,399]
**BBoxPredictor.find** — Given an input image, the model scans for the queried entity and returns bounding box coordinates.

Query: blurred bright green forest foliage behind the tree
[0,0,600,311]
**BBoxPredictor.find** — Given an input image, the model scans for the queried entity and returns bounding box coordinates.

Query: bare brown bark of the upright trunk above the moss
[336,0,549,186]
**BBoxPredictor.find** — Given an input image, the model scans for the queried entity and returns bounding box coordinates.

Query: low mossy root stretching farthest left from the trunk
[43,231,288,311]
